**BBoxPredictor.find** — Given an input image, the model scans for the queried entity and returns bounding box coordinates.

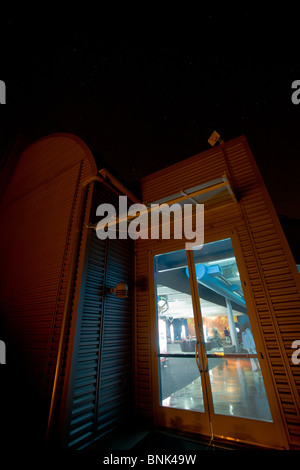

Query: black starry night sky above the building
[0,5,300,226]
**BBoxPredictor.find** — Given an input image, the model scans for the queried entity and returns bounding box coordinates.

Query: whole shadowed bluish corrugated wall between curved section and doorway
[64,184,133,449]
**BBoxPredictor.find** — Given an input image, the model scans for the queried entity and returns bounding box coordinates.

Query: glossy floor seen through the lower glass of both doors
[162,358,272,422]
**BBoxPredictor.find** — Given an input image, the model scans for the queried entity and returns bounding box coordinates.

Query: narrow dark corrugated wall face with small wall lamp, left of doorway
[97,239,133,435]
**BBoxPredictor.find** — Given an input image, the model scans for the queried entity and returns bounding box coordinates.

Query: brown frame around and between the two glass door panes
[148,237,289,449]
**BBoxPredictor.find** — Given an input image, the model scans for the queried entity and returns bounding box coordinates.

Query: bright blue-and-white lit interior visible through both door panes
[155,239,272,421]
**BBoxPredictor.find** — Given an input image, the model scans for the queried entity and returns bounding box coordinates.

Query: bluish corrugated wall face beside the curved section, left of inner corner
[68,233,106,447]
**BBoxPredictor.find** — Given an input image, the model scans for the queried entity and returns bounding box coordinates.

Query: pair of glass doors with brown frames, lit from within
[154,239,284,447]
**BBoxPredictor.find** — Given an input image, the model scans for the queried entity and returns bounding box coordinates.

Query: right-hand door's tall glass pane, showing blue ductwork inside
[191,239,272,421]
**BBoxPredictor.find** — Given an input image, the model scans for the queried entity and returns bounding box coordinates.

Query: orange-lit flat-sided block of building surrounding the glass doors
[135,136,300,448]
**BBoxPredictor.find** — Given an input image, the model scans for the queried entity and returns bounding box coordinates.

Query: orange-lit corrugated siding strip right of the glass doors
[225,140,300,446]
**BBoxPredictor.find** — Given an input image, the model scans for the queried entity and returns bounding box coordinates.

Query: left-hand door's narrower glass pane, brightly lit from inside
[154,250,204,412]
